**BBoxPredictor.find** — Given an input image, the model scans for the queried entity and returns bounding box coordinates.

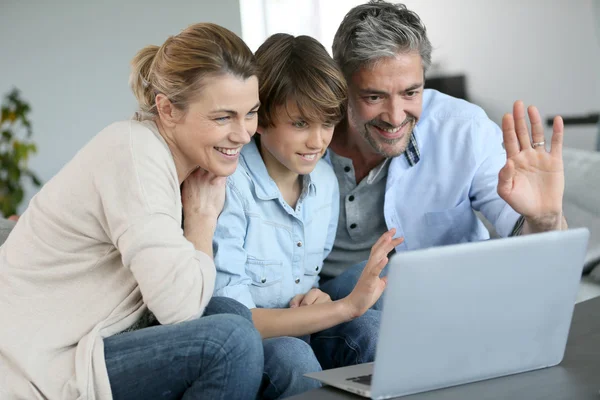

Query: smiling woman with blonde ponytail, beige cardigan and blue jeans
[0,24,263,399]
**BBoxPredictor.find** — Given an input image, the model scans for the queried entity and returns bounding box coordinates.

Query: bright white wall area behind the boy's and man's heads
[241,0,600,149]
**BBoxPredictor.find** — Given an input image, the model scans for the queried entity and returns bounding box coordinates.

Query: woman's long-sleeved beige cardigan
[0,121,215,400]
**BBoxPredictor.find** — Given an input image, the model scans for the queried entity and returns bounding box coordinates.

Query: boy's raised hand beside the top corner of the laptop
[342,228,404,319]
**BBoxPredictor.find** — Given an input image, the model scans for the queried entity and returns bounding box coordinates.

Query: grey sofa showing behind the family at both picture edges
[0,148,600,300]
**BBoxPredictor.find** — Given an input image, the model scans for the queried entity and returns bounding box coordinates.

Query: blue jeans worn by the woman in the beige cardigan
[104,297,264,400]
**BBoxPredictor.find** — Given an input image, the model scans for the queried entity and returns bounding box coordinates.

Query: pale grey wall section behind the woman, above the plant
[0,0,242,210]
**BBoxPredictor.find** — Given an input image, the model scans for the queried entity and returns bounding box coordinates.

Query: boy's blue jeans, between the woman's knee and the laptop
[213,296,381,400]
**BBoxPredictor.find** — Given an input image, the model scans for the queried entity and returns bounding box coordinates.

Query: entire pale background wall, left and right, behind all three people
[0,0,600,211]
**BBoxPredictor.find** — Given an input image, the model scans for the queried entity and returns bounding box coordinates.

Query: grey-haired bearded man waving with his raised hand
[322,0,567,299]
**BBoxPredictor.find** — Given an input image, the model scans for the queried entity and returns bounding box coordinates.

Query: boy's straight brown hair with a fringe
[255,33,347,128]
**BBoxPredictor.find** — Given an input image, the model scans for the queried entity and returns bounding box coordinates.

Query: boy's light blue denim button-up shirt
[213,140,339,308]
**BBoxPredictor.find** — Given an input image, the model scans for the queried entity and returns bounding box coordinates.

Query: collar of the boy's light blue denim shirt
[240,138,317,200]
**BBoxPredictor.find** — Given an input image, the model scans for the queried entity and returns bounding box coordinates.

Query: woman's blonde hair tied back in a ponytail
[129,23,257,121]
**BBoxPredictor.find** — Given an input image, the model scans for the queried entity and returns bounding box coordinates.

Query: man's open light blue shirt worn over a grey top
[376,89,520,251]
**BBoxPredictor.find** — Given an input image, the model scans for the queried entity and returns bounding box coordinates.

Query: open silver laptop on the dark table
[306,228,589,399]
